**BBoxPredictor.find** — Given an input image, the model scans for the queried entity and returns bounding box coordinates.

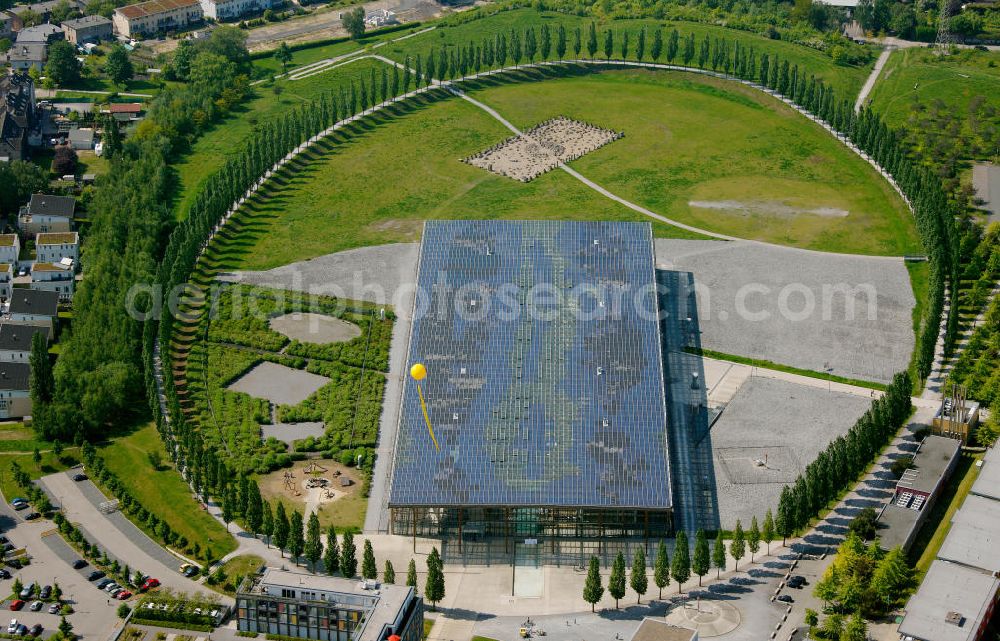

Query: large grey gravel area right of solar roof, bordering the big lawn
[656,239,915,382]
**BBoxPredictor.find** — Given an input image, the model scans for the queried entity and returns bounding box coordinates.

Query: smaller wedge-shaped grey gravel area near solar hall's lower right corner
[712,377,871,529]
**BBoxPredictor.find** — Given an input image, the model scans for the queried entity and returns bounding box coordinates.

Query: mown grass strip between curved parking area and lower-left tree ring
[100,425,236,558]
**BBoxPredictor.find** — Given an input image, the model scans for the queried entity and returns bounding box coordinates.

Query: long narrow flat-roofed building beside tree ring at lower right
[878,435,962,551]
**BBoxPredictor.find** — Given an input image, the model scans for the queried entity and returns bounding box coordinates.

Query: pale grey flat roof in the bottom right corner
[899,561,1000,641]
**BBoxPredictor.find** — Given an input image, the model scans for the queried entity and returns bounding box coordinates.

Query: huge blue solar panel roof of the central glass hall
[389,221,671,509]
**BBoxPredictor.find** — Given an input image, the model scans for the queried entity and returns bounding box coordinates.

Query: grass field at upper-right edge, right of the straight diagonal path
[869,48,1000,127]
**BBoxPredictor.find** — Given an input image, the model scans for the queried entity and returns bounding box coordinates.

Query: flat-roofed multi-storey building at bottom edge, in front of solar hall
[236,568,424,641]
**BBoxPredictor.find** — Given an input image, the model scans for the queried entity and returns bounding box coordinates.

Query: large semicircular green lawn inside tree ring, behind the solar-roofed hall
[221,65,917,269]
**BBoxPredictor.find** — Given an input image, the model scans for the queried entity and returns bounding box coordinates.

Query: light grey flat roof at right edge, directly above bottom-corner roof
[938,494,1000,572]
